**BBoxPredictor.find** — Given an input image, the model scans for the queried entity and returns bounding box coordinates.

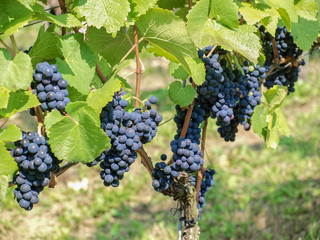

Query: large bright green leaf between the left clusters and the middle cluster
[45,102,110,163]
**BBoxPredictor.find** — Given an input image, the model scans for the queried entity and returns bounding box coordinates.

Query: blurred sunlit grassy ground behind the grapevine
[0,24,320,240]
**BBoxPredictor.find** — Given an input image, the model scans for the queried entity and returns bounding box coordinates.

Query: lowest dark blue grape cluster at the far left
[11,132,61,210]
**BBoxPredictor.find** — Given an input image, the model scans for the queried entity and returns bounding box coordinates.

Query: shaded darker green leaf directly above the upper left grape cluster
[29,26,62,66]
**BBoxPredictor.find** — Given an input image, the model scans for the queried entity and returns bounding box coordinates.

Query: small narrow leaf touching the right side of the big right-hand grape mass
[251,105,269,139]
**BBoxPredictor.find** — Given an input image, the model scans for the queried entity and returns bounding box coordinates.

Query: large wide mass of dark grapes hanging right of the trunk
[197,47,268,141]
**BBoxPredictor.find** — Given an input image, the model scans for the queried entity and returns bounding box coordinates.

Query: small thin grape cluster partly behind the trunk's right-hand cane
[190,169,216,218]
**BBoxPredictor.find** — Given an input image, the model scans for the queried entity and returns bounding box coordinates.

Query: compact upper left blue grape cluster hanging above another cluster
[31,62,70,112]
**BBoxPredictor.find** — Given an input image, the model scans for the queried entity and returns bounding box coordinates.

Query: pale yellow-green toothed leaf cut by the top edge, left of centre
[74,0,130,33]
